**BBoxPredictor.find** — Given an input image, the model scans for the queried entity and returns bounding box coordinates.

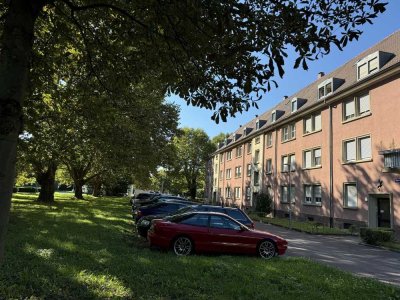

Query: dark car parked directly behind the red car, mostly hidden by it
[136,204,254,237]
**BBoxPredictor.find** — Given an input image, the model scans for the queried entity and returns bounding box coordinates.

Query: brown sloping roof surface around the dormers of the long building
[217,30,400,152]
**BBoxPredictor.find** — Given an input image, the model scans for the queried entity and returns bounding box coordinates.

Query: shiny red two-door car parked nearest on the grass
[148,212,288,259]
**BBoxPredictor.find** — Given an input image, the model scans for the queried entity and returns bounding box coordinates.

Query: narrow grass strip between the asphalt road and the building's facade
[250,214,352,235]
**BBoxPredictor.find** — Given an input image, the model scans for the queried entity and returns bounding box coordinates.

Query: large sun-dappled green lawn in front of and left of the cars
[0,194,400,299]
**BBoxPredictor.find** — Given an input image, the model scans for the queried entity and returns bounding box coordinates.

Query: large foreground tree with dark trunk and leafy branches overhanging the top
[0,0,385,257]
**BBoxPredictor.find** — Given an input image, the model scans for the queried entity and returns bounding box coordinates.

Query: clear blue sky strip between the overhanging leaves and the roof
[168,0,400,138]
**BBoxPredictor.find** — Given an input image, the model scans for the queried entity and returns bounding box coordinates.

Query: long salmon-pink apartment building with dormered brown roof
[212,31,400,235]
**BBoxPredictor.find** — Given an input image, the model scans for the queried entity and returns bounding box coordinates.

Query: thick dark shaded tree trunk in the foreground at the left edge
[0,0,42,263]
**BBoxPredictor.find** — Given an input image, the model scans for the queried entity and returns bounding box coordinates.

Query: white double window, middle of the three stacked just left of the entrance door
[343,135,372,163]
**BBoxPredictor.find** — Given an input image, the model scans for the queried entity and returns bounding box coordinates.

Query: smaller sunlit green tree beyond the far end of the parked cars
[169,128,215,199]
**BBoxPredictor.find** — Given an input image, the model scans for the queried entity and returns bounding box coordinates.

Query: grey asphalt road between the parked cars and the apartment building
[255,223,400,286]
